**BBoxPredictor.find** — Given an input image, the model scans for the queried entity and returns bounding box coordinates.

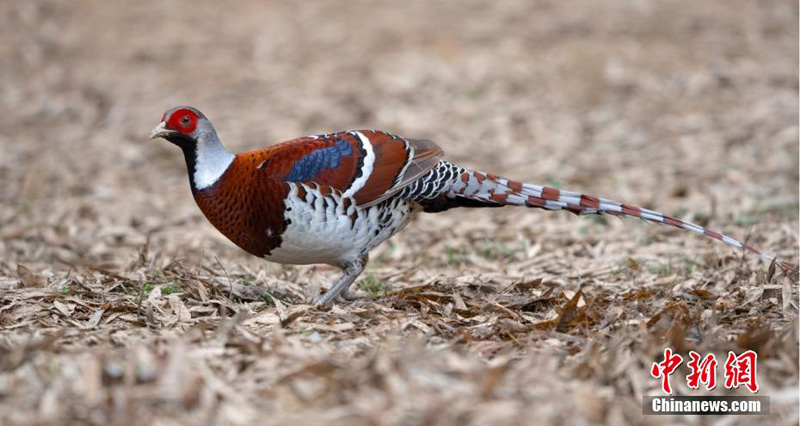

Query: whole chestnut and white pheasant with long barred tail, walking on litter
[150,106,793,306]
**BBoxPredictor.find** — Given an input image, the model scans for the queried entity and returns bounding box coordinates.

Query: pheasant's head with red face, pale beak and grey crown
[150,106,214,149]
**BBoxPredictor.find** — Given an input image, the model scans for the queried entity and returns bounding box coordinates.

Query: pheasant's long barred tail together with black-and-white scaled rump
[407,161,797,275]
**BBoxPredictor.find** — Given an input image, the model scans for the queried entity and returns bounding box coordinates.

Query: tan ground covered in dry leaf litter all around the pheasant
[0,0,798,425]
